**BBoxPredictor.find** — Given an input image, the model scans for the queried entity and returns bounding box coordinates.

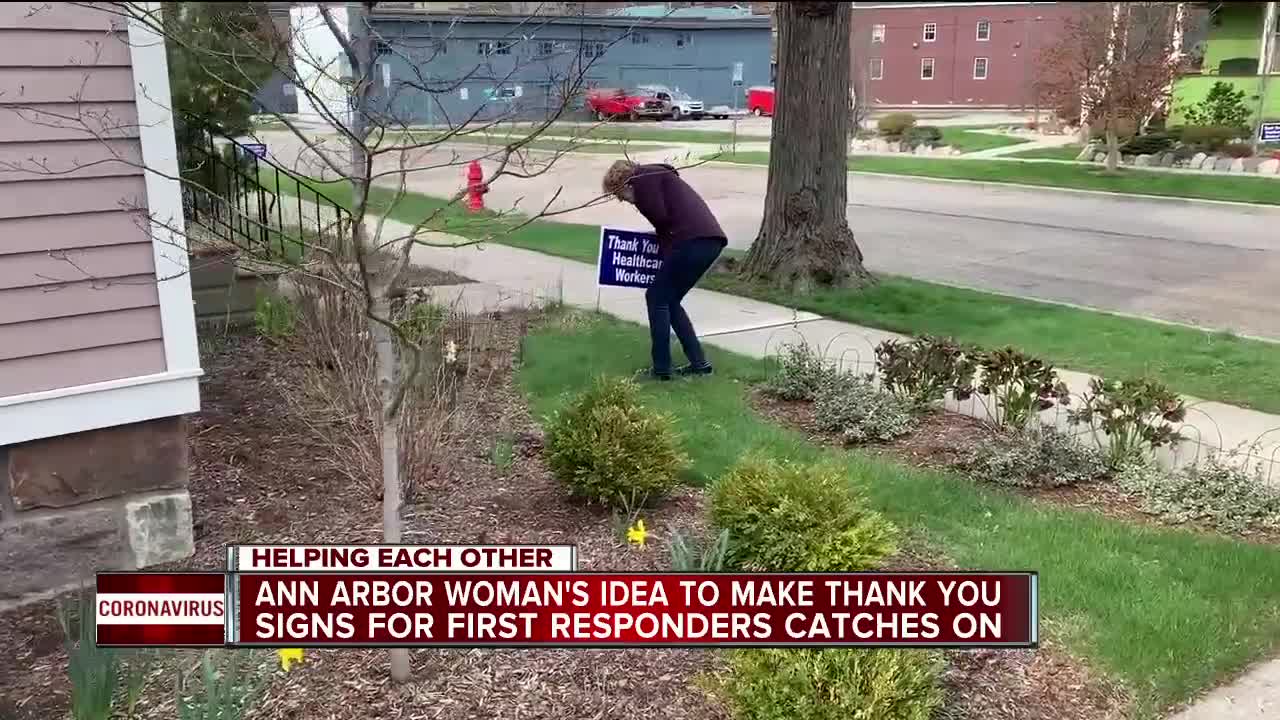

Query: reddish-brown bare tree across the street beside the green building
[1039,3,1181,172]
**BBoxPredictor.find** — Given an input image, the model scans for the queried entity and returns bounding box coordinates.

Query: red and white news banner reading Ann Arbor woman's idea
[96,546,1039,648]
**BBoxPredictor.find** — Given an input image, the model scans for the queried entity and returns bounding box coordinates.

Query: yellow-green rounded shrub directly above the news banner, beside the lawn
[712,456,896,573]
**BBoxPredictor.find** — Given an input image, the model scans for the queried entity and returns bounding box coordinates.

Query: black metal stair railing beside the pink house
[178,123,351,261]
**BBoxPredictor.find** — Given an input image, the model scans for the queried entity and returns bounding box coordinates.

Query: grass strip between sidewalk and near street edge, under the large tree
[264,172,1280,413]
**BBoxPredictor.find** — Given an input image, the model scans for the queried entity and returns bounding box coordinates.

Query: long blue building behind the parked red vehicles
[370,12,771,124]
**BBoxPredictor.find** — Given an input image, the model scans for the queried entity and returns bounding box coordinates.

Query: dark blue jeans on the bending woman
[644,237,726,375]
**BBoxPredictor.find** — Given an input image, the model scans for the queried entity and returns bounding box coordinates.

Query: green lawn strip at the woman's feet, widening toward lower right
[520,313,1280,716]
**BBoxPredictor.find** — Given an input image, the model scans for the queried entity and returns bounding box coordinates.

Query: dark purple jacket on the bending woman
[627,164,727,258]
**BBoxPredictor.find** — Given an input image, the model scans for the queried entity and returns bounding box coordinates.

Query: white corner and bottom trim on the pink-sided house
[0,3,202,445]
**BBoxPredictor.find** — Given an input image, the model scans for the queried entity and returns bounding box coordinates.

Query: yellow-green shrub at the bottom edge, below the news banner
[721,648,942,720]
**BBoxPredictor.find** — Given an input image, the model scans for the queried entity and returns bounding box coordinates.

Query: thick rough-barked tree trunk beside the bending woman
[742,3,872,292]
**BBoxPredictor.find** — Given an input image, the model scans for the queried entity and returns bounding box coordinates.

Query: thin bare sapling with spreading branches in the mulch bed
[9,3,670,682]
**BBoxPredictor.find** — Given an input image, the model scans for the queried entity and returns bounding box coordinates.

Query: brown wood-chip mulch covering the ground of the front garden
[0,313,1126,720]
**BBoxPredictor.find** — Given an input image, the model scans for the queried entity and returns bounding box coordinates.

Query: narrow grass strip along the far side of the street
[707,152,1280,205]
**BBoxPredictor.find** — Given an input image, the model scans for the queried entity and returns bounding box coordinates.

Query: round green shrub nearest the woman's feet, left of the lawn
[547,378,686,507]
